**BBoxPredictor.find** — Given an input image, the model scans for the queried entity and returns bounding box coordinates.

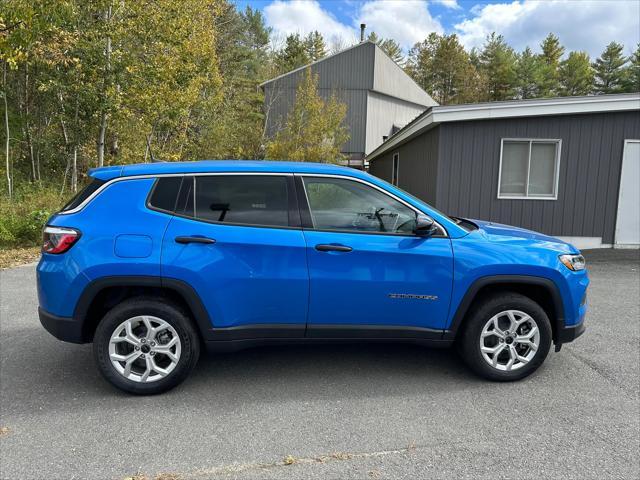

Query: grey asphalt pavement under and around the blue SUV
[0,250,640,480]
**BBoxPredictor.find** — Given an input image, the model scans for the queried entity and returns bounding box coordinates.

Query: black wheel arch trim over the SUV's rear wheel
[73,276,212,342]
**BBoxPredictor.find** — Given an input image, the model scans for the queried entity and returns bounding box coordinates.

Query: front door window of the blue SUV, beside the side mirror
[304,177,416,233]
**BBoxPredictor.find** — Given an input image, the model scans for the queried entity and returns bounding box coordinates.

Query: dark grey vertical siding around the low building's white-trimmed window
[436,112,640,243]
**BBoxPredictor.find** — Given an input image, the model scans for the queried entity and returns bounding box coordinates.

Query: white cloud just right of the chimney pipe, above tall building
[354,0,443,49]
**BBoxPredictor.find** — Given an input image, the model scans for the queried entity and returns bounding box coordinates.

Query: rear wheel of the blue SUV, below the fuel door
[93,297,200,395]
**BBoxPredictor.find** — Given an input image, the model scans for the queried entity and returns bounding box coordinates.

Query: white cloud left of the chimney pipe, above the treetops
[264,0,356,46]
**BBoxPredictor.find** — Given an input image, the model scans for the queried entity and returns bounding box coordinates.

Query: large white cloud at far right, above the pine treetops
[454,0,640,57]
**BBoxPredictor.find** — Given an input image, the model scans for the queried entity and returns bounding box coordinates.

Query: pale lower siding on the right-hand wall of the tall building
[365,92,425,154]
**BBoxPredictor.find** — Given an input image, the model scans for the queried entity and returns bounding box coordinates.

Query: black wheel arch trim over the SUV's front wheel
[443,275,564,342]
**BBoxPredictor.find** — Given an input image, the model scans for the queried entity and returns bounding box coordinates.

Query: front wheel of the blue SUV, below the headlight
[459,292,552,382]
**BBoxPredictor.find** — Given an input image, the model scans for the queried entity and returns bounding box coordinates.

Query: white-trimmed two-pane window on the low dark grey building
[498,138,562,200]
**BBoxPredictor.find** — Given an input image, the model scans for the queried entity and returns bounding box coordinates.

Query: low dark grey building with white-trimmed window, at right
[367,94,640,248]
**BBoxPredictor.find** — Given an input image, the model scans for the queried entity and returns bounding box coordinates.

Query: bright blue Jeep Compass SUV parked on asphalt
[37,161,589,394]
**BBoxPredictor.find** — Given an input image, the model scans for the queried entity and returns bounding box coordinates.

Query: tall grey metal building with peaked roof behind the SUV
[261,41,437,166]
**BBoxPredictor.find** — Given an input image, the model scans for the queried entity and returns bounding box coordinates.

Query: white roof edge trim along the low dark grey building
[366,93,640,161]
